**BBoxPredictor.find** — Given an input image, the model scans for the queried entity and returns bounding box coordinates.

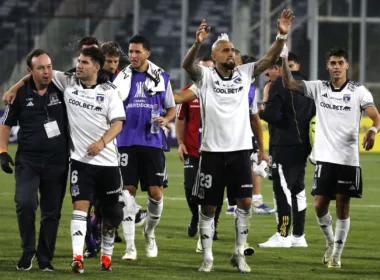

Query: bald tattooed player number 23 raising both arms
[182,10,294,273]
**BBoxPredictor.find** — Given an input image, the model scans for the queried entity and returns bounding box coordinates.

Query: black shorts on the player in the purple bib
[119,146,167,191]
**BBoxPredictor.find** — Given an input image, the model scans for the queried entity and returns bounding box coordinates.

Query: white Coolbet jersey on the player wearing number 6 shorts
[53,71,125,166]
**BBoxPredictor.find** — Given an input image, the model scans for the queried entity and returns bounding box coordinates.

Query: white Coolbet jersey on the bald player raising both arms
[194,63,254,152]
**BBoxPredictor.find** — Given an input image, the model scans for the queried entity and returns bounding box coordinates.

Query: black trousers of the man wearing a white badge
[15,153,69,263]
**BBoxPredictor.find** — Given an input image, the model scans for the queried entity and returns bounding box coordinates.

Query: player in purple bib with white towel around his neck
[114,35,176,260]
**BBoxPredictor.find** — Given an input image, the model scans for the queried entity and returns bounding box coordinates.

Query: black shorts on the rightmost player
[311,161,363,199]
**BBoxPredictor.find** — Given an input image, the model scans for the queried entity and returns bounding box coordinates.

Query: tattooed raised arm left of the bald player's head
[182,19,211,82]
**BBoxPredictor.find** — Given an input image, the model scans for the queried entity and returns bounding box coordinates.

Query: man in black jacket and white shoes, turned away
[259,54,315,248]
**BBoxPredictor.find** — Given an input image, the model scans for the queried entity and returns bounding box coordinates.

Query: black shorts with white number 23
[192,150,253,206]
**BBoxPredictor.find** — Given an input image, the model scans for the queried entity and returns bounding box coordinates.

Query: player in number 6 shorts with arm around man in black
[6,47,125,273]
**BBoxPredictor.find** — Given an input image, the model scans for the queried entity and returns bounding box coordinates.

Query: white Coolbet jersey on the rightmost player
[303,81,374,166]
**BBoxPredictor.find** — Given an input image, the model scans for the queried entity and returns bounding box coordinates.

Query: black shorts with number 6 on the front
[70,159,122,205]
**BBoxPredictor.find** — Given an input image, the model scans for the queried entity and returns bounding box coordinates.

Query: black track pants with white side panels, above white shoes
[272,162,306,237]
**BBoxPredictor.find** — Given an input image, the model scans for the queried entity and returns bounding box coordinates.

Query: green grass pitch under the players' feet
[0,146,380,280]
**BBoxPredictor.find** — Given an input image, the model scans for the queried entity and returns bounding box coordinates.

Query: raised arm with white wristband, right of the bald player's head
[253,10,294,76]
